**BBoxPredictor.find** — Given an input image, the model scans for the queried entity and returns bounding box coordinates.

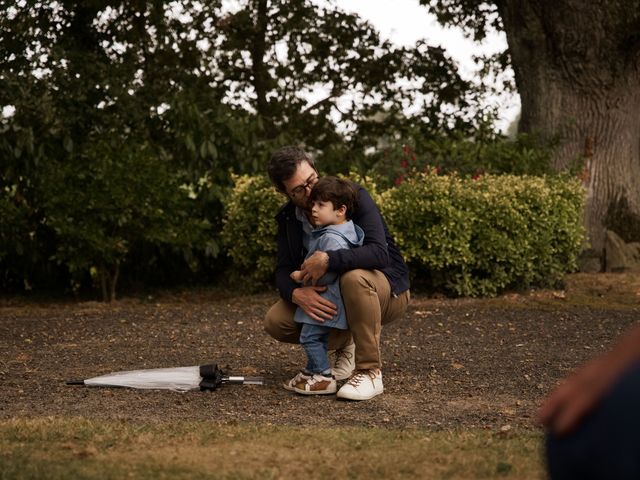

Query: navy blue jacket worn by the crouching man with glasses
[276,184,409,301]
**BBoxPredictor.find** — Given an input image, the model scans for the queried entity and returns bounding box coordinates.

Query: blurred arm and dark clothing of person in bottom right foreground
[538,326,640,480]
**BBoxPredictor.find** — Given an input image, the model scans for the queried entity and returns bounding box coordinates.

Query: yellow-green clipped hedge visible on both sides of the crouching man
[223,173,584,296]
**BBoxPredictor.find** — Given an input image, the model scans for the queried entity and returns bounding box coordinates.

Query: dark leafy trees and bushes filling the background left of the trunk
[0,0,500,298]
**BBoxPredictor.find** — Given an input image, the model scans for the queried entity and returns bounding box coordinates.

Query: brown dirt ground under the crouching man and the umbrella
[0,275,640,430]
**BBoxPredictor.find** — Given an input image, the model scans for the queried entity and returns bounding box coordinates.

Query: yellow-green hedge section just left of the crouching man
[222,175,284,289]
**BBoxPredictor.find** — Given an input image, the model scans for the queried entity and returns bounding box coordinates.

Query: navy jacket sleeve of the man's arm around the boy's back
[327,186,389,273]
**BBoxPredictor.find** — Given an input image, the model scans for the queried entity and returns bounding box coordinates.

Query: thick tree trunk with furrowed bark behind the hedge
[498,0,640,258]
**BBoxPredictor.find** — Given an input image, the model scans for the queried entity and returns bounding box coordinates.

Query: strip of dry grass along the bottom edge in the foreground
[0,418,544,479]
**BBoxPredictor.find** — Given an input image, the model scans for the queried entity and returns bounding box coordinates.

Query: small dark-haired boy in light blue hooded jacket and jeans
[284,177,364,395]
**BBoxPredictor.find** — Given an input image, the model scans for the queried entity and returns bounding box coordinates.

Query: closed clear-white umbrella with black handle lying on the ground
[67,363,264,392]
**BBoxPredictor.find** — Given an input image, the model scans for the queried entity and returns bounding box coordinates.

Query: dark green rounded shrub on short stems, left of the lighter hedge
[40,144,211,301]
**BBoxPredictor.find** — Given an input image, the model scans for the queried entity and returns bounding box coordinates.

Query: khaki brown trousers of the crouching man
[264,269,410,370]
